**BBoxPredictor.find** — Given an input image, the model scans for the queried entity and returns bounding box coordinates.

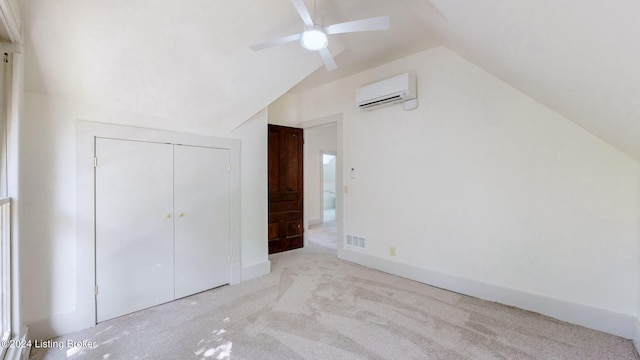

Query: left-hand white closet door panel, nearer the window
[95,139,174,322]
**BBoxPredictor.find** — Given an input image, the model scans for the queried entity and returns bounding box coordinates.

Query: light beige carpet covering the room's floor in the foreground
[32,245,640,360]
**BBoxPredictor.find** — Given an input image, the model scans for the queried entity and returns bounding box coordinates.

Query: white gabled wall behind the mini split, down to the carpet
[271,47,640,338]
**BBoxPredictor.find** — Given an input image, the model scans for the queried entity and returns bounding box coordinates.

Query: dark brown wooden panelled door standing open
[268,125,304,254]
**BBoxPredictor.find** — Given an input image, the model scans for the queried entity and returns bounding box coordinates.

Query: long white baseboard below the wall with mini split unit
[338,249,640,338]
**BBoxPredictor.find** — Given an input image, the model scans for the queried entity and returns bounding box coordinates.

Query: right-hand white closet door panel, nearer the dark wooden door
[174,145,230,299]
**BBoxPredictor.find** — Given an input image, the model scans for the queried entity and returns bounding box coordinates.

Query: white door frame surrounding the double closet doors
[75,120,242,327]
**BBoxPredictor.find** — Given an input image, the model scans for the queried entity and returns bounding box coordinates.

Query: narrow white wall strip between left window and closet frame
[20,93,82,331]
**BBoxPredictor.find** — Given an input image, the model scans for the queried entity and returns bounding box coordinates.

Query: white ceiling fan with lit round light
[250,0,389,71]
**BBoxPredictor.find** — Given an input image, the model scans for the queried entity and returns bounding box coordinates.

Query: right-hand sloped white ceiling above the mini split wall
[424,0,640,160]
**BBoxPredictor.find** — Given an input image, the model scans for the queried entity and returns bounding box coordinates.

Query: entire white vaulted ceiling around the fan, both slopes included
[21,0,640,160]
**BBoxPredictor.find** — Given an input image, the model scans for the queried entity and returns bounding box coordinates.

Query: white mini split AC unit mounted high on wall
[356,73,417,110]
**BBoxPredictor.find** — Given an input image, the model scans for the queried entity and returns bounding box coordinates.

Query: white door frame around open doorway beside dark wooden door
[296,113,348,252]
